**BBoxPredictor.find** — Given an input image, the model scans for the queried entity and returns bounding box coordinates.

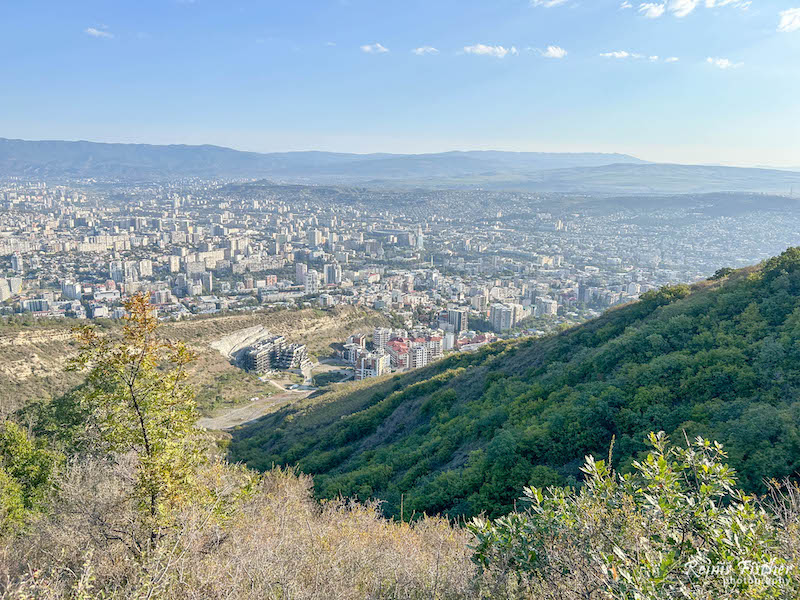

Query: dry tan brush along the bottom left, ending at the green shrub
[0,463,481,600]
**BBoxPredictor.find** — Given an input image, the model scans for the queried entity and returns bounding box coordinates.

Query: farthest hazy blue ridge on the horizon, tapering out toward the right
[0,138,643,182]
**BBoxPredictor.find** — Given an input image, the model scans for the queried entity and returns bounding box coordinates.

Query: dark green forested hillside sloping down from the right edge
[231,248,800,518]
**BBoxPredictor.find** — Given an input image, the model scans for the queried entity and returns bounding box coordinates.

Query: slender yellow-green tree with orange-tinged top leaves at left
[73,294,203,525]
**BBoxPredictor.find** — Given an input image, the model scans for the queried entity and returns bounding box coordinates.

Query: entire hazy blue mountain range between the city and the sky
[0,138,800,194]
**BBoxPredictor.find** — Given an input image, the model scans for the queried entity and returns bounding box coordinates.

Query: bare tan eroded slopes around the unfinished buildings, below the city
[0,307,385,418]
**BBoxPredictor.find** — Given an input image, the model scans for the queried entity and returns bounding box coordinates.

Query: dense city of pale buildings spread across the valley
[0,180,800,380]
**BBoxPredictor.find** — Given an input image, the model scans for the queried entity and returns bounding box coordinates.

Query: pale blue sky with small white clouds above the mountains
[0,0,800,167]
